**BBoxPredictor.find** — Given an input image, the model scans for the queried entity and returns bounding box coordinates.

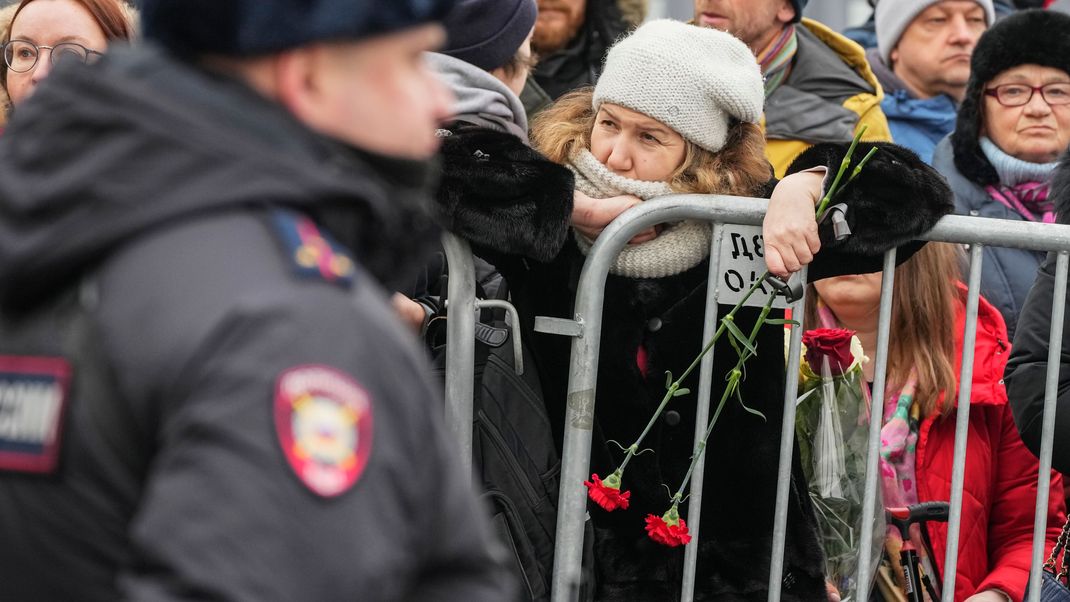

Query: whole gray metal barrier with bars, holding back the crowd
[436,195,1070,602]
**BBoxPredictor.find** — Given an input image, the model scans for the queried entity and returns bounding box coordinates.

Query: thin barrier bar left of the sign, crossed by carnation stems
[679,223,724,602]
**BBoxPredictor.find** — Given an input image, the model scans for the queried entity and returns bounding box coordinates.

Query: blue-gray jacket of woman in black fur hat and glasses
[933,138,1044,338]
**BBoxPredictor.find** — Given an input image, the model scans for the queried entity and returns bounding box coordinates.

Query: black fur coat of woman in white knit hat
[440,129,951,602]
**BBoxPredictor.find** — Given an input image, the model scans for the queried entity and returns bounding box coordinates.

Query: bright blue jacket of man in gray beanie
[881,90,958,165]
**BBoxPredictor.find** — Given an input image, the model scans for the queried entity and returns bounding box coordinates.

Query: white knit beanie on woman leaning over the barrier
[593,19,765,153]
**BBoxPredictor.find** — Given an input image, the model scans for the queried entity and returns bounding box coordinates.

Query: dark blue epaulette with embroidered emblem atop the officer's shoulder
[271,210,355,287]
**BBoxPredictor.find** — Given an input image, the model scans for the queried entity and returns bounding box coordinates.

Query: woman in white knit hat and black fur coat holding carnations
[436,21,950,601]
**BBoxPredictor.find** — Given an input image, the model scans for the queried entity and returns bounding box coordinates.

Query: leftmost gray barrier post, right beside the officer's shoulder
[442,233,475,479]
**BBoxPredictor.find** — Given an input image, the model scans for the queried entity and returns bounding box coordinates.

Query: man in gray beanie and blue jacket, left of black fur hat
[867,0,995,161]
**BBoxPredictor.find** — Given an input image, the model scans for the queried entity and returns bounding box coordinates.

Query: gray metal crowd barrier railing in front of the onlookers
[438,195,1070,602]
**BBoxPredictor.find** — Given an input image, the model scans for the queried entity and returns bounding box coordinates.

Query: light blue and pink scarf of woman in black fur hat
[980,137,1058,223]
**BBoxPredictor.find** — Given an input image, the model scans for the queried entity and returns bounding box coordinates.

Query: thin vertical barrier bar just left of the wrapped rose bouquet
[768,266,807,602]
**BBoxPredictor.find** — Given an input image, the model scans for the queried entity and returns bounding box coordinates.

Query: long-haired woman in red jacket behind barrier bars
[807,243,1065,602]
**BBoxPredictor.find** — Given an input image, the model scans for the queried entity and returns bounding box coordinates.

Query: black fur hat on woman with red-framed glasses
[951,10,1070,186]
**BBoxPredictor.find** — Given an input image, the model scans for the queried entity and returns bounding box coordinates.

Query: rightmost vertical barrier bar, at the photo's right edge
[1026,251,1070,602]
